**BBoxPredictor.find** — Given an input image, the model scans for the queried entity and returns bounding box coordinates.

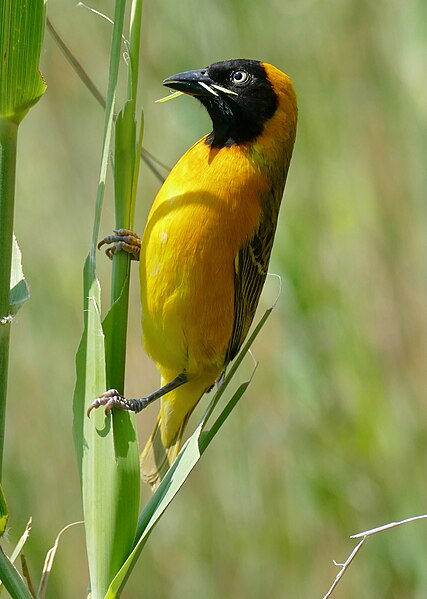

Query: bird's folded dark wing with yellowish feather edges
[226,204,277,364]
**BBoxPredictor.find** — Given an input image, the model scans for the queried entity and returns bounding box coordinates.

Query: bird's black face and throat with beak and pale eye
[163,59,278,147]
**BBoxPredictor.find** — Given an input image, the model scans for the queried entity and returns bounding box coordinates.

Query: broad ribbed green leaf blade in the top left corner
[0,0,46,123]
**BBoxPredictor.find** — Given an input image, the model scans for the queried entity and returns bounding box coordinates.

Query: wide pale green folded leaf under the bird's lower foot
[74,257,139,599]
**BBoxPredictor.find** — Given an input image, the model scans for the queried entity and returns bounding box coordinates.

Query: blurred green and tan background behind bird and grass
[4,0,427,599]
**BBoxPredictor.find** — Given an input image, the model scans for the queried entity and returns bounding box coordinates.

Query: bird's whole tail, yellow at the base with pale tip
[141,380,210,491]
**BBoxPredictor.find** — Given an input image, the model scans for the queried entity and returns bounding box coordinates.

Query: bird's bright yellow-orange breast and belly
[140,140,268,378]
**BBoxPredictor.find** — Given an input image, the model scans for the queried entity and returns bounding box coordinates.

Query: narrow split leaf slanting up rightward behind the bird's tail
[105,306,274,599]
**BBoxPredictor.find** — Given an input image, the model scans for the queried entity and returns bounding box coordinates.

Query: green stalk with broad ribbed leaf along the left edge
[0,0,46,479]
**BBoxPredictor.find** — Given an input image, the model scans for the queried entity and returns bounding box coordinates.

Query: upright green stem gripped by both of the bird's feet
[98,81,140,596]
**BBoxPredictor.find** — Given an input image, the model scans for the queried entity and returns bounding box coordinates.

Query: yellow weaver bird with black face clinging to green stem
[89,59,297,487]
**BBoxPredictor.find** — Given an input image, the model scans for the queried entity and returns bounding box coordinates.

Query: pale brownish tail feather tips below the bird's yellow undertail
[141,412,191,491]
